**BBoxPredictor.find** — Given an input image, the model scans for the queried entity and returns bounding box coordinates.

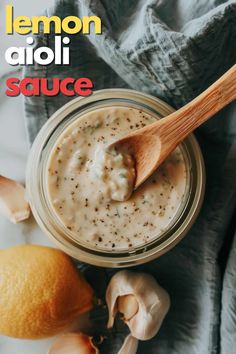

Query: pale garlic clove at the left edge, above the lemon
[0,176,30,223]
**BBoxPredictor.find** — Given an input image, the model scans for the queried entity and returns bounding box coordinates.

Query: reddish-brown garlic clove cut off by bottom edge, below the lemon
[48,333,99,354]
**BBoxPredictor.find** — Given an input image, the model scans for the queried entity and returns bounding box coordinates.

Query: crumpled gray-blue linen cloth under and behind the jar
[24,0,236,354]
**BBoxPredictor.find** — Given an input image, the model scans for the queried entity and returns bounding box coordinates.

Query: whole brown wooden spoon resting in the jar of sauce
[111,65,236,189]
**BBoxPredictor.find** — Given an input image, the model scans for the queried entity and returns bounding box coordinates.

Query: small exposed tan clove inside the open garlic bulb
[117,294,139,321]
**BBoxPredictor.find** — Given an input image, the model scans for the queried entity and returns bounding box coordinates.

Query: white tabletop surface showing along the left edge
[0,0,61,354]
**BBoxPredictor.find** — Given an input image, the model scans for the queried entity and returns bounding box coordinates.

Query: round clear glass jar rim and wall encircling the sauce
[26,89,205,267]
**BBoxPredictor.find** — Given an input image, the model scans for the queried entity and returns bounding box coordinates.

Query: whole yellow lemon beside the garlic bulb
[0,245,93,339]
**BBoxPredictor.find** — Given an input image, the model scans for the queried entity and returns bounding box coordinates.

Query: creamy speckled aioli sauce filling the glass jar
[47,107,188,250]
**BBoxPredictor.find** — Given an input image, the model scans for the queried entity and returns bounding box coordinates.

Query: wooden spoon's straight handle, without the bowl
[156,65,236,148]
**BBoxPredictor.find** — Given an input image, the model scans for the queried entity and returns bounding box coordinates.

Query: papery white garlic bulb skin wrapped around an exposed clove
[106,270,170,340]
